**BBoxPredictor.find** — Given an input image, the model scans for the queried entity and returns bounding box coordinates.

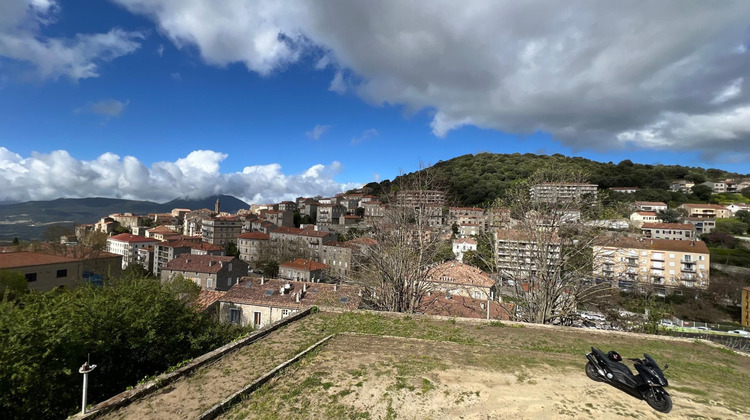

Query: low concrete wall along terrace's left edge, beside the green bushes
[70,309,311,419]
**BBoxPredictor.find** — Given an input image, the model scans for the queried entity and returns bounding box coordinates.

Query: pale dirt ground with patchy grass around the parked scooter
[222,335,750,419]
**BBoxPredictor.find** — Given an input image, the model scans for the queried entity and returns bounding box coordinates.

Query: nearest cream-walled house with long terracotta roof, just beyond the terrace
[219,277,362,328]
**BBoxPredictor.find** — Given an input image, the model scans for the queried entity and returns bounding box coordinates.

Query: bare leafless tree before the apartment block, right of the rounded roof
[500,167,616,324]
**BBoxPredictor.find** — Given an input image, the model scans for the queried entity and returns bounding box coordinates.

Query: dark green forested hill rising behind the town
[367,153,747,206]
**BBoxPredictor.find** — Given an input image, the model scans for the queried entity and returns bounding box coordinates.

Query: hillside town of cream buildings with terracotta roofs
[5,180,750,334]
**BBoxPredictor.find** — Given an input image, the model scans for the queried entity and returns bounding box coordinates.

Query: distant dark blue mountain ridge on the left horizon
[0,195,250,240]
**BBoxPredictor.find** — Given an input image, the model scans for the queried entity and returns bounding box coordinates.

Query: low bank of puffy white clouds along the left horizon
[0,147,360,203]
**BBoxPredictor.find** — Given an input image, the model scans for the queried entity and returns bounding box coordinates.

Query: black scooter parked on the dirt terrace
[586,347,672,413]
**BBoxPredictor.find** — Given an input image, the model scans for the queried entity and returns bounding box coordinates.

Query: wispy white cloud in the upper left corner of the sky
[0,0,144,81]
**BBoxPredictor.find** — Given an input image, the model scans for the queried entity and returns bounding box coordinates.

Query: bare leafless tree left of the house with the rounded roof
[352,164,450,312]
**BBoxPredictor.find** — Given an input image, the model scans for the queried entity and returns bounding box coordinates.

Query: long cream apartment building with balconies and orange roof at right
[593,238,711,294]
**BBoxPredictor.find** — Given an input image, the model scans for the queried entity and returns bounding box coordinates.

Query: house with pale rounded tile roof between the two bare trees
[425,261,497,300]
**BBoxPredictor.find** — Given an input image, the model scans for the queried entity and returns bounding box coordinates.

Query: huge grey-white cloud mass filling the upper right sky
[115,0,750,158]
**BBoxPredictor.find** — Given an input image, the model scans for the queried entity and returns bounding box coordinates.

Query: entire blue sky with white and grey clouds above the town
[0,0,750,203]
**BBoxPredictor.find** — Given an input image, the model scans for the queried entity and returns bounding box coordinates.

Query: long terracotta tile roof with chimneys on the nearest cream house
[220,277,362,310]
